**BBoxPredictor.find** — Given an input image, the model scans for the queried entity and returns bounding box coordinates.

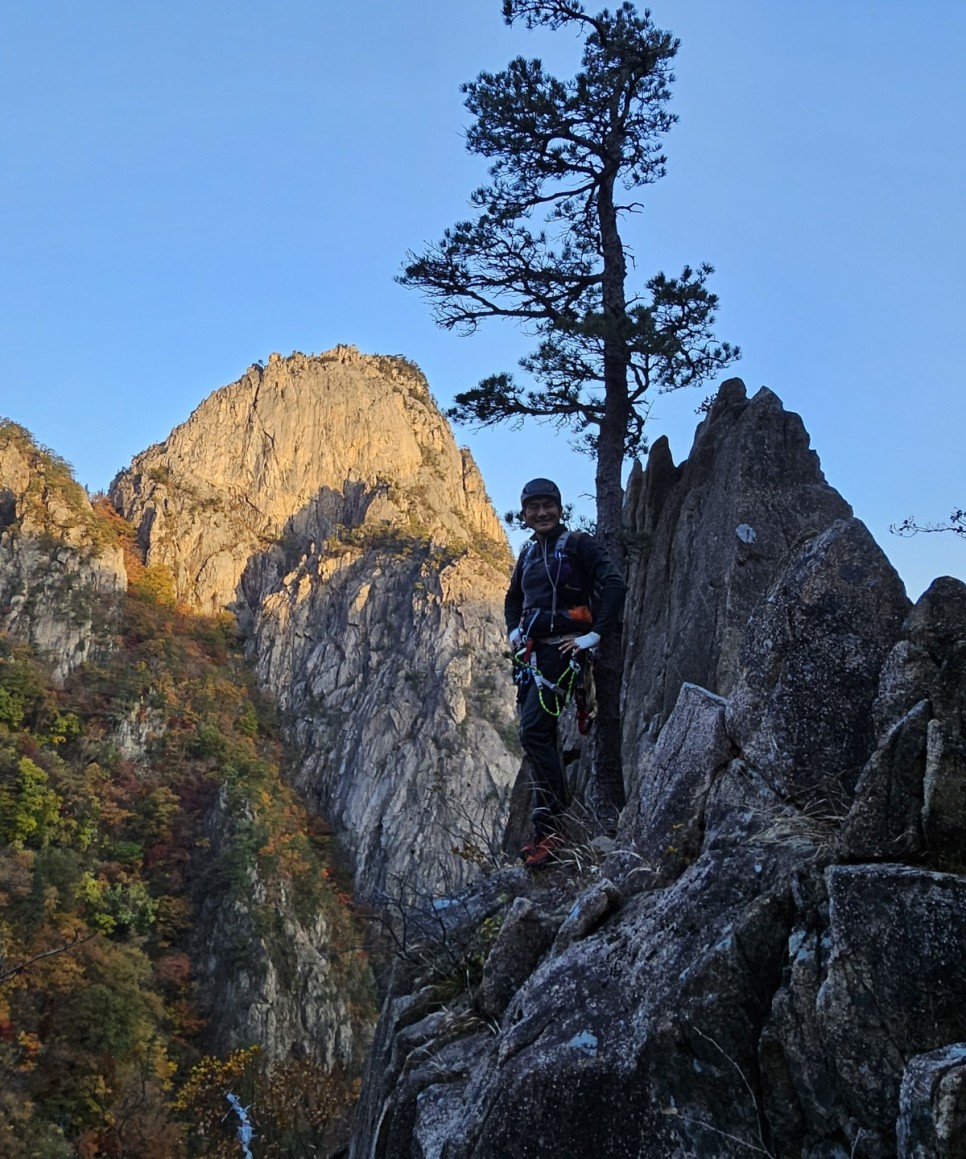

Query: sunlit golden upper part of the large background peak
[110,345,507,611]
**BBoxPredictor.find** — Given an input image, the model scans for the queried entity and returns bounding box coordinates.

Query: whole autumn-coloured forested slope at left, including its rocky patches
[0,423,373,1159]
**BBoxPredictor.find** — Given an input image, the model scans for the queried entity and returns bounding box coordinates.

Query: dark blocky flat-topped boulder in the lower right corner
[763,865,966,1159]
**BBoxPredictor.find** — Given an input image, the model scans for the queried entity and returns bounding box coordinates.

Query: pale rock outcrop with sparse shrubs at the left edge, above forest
[0,420,126,684]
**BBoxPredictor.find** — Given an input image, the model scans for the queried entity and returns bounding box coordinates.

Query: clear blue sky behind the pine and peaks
[0,0,966,597]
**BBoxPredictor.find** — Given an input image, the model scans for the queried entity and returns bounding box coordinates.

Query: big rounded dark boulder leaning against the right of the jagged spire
[727,519,910,815]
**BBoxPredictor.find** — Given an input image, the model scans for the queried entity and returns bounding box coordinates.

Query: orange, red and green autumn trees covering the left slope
[0,500,375,1159]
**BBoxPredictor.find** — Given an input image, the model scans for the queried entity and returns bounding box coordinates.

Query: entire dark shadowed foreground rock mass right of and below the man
[351,381,966,1159]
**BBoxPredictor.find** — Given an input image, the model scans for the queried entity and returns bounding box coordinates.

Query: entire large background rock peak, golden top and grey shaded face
[110,347,520,897]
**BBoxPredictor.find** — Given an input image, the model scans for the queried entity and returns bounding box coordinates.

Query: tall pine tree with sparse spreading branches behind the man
[399,0,739,808]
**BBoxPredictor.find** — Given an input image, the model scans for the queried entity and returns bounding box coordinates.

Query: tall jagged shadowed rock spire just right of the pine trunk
[624,379,852,748]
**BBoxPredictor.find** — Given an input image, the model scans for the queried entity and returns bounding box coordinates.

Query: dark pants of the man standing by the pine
[520,641,579,837]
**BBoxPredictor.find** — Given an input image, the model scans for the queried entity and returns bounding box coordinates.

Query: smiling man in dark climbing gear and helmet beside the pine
[504,479,627,867]
